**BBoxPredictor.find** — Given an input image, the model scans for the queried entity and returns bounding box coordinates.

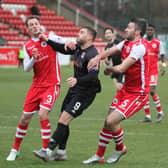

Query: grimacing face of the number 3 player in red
[27,18,41,37]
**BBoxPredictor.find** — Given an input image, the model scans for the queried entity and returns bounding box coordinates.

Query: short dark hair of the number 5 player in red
[131,18,147,37]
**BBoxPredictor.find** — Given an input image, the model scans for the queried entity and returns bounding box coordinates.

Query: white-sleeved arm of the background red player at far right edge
[159,42,166,75]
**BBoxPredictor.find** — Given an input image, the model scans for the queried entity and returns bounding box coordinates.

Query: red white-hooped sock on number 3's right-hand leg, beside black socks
[40,119,51,149]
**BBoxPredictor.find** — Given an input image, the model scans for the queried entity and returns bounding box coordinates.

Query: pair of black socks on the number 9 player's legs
[48,123,69,150]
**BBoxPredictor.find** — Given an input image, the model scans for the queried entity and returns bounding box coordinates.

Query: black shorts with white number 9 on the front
[61,91,96,118]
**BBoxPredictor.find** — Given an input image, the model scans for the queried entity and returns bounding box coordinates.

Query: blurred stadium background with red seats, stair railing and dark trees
[0,0,168,66]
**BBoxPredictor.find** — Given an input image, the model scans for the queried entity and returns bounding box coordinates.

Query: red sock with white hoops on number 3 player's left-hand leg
[13,123,28,151]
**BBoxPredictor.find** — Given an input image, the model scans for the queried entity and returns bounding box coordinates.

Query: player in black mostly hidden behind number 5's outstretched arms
[104,27,124,92]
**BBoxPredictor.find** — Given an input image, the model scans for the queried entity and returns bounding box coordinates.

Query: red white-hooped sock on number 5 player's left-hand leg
[96,128,112,157]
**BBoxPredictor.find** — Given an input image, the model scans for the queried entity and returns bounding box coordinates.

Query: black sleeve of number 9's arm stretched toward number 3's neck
[47,39,75,54]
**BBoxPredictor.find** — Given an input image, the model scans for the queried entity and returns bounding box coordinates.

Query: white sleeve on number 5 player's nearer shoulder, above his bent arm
[130,44,146,60]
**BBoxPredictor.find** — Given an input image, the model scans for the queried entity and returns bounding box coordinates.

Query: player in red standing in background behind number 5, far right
[143,24,166,122]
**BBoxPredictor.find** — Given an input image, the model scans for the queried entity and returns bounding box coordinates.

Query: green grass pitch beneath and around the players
[0,66,168,168]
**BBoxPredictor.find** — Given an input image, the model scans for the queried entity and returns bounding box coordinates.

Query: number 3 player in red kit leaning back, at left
[7,16,74,161]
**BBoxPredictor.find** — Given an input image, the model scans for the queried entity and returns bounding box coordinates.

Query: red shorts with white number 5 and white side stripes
[111,89,149,118]
